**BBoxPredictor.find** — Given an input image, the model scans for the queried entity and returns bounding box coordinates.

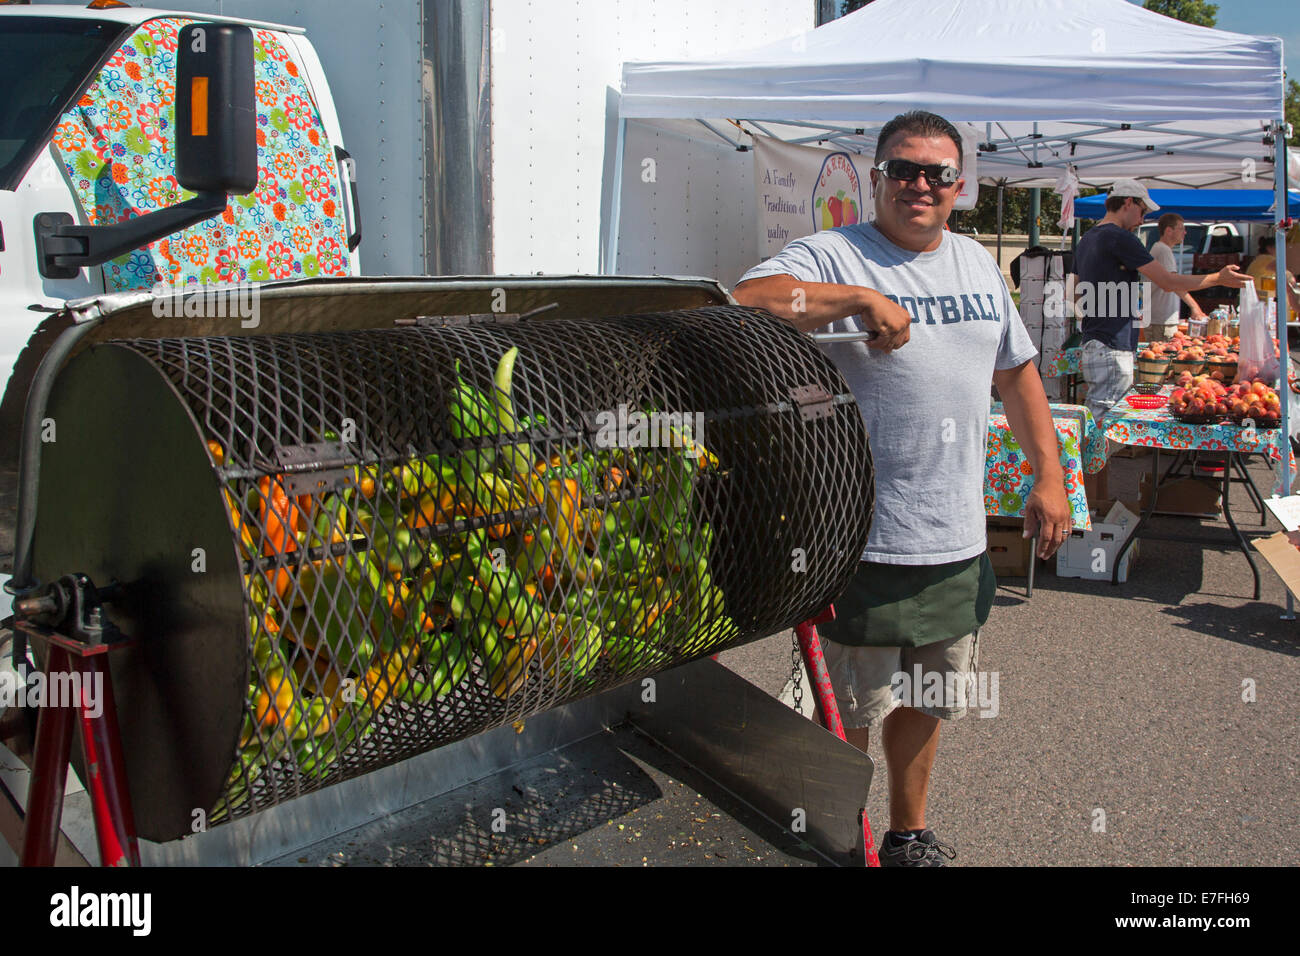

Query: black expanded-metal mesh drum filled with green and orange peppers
[120,307,872,823]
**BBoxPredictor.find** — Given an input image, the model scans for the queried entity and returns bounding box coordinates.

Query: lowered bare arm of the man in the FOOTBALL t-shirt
[993,362,1082,558]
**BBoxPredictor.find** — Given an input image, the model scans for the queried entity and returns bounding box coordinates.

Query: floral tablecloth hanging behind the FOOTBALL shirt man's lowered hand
[984,402,1106,531]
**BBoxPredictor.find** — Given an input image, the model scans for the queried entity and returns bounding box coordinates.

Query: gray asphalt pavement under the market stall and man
[720,450,1300,866]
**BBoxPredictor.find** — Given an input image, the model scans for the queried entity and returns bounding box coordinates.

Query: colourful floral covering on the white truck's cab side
[53,17,348,291]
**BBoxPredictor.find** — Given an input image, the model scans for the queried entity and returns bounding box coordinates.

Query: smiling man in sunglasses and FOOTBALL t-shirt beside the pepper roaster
[736,112,1070,866]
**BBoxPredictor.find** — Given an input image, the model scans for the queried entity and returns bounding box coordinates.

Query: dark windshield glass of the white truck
[0,16,129,190]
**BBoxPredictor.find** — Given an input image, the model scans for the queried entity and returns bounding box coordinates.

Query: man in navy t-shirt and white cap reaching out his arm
[1074,179,1249,421]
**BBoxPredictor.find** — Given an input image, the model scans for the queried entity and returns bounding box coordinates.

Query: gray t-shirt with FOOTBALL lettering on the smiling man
[741,222,1037,564]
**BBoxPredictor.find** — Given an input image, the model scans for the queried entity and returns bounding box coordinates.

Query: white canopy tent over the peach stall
[603,0,1290,600]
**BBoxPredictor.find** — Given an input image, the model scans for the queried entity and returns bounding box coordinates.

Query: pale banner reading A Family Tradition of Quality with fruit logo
[754,137,872,259]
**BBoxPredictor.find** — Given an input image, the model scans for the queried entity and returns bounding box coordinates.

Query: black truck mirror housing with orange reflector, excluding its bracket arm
[176,23,257,195]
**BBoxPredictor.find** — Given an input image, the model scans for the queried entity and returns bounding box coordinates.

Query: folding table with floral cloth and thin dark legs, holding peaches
[1101,385,1284,601]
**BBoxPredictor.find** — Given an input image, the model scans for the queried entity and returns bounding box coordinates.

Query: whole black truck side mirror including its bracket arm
[33,23,257,278]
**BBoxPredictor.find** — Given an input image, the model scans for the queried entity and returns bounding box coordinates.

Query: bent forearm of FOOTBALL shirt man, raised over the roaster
[732,274,911,352]
